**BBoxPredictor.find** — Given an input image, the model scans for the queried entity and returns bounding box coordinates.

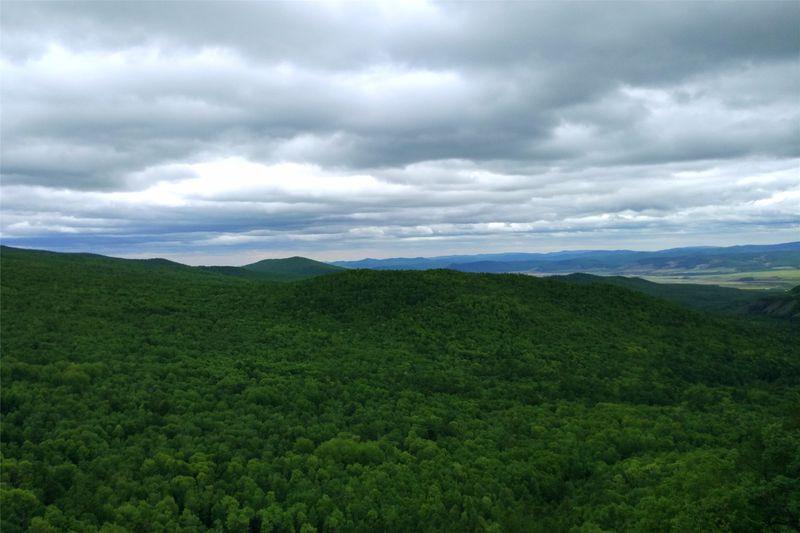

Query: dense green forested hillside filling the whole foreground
[0,250,800,533]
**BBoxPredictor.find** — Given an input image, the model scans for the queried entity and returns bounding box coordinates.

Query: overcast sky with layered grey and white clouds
[0,1,800,264]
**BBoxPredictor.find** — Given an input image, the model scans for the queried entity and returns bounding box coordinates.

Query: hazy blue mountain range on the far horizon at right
[333,242,800,275]
